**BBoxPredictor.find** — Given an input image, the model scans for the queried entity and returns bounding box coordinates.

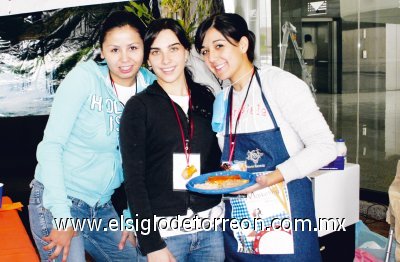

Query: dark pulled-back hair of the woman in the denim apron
[194,13,256,62]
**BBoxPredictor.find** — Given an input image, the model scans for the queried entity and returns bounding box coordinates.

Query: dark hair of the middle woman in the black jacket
[143,18,193,82]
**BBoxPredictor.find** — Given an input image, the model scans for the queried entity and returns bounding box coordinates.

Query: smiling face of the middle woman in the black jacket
[148,29,189,87]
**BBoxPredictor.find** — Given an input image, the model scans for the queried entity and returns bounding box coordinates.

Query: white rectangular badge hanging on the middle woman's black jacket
[172,153,201,190]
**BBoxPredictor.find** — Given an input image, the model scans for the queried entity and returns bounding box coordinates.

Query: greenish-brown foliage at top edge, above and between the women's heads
[125,0,212,40]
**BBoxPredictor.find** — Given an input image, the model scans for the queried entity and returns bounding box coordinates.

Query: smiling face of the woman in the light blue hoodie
[101,25,143,86]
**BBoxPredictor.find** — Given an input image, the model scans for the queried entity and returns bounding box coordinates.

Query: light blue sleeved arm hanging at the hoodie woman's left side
[37,64,93,225]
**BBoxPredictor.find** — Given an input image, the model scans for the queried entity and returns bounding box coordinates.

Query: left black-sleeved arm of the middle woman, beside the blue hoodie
[120,96,166,255]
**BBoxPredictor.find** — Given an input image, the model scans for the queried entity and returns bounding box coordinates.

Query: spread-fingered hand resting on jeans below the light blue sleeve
[43,227,77,262]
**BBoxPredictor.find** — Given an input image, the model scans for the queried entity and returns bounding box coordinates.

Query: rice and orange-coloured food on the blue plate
[194,175,249,190]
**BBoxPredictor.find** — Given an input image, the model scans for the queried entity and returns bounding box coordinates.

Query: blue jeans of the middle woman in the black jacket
[138,227,225,262]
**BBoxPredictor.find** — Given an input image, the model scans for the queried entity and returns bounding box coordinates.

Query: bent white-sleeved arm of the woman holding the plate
[272,71,336,183]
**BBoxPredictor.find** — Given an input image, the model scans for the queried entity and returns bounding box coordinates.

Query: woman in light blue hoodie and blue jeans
[29,11,155,262]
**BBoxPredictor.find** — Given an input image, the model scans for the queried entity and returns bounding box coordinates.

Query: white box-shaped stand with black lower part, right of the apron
[309,164,360,261]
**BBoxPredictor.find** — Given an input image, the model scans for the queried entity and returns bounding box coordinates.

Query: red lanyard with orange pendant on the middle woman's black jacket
[170,85,197,179]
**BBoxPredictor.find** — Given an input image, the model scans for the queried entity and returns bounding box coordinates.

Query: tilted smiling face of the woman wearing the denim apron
[200,27,251,82]
